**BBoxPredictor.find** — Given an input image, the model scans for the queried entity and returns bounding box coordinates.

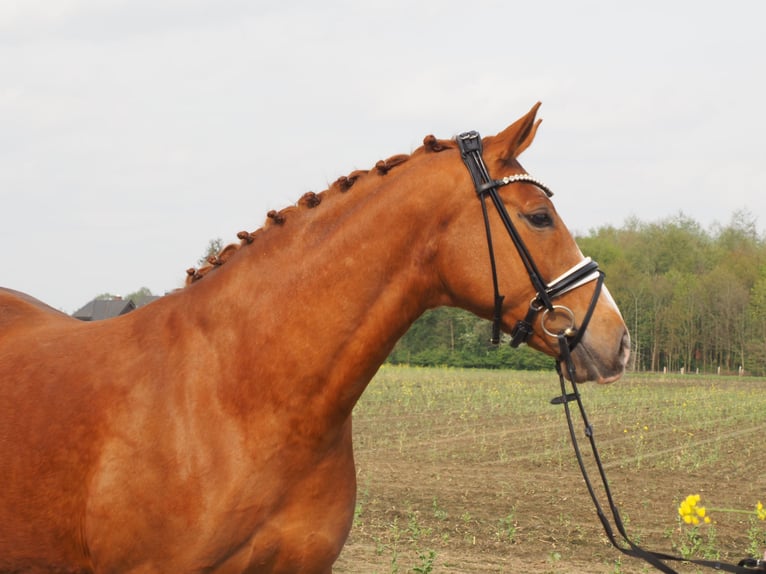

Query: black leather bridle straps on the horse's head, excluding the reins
[457,131,604,351]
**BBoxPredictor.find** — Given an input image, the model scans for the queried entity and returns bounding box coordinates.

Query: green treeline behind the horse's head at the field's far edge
[389,211,766,375]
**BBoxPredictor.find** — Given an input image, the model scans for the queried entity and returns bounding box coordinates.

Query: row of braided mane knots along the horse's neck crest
[185,135,455,286]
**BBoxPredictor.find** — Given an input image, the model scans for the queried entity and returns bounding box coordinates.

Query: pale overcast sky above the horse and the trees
[0,0,766,313]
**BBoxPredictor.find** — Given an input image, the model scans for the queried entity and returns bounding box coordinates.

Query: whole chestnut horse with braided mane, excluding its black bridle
[0,104,629,573]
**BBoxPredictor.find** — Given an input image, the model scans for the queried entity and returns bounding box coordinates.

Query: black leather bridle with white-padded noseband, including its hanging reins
[457,131,766,574]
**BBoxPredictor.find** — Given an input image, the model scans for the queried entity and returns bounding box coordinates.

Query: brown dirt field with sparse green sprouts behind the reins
[334,366,766,574]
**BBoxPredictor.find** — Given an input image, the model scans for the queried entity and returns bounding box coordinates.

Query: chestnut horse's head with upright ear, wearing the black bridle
[437,104,630,383]
